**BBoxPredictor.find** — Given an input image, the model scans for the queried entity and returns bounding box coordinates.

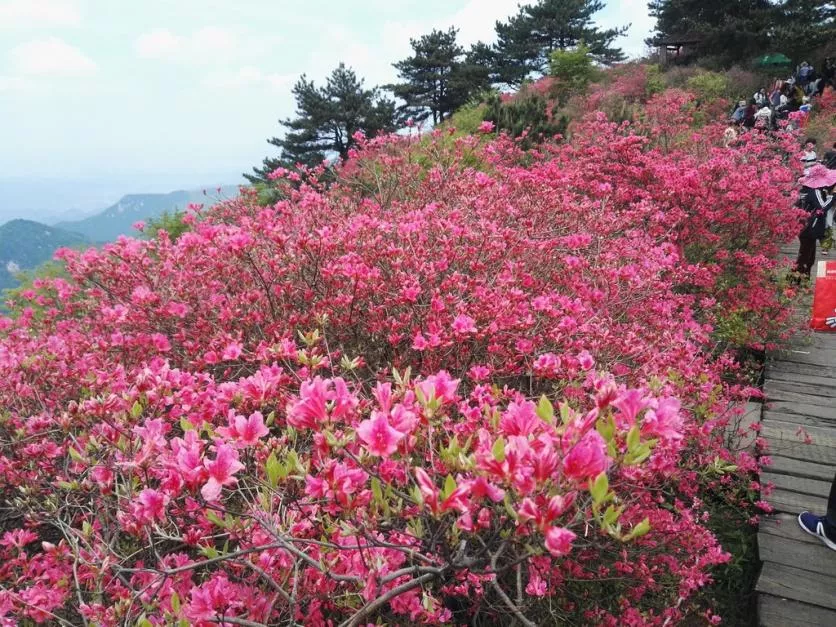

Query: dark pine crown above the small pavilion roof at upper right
[648,0,778,66]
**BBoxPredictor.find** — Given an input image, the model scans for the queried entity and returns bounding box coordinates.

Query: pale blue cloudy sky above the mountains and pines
[0,0,652,219]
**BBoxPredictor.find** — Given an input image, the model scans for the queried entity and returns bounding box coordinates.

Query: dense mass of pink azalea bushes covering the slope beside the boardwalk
[0,92,797,625]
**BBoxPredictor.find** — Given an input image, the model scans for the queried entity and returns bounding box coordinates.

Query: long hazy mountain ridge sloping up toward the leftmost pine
[55,185,238,243]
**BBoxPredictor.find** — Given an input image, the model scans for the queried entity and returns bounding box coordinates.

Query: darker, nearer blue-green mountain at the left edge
[0,220,90,290]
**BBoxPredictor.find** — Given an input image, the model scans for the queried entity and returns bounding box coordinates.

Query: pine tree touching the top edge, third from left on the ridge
[494,0,629,85]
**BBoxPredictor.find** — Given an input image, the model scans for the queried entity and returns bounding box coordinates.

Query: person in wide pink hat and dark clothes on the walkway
[795,165,836,279]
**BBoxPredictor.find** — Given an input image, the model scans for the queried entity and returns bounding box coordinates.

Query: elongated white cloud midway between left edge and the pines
[134,26,277,65]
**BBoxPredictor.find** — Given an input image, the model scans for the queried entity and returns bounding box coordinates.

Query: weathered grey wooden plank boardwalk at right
[757,248,836,627]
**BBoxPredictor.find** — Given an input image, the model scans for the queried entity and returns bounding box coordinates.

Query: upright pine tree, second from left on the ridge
[388,28,489,124]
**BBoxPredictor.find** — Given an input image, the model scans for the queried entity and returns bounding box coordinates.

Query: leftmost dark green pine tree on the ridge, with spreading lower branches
[244,63,397,183]
